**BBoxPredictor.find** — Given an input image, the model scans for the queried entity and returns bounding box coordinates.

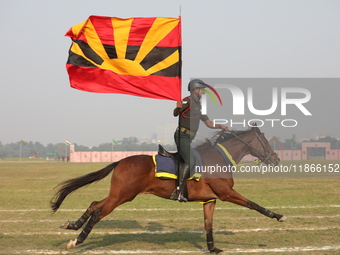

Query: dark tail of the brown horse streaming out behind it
[50,161,119,212]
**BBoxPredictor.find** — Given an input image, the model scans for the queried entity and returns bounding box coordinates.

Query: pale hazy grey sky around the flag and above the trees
[0,0,340,146]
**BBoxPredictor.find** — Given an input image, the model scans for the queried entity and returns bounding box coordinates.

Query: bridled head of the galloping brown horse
[249,124,280,166]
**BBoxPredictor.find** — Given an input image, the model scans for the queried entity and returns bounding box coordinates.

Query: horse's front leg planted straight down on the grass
[203,201,223,254]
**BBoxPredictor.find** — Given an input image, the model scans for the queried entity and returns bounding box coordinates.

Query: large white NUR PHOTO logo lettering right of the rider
[202,83,312,127]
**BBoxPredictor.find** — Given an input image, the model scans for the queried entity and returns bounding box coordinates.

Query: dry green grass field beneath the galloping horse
[0,161,340,255]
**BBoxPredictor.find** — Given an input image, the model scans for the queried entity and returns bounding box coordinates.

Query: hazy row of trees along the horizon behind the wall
[0,136,340,158]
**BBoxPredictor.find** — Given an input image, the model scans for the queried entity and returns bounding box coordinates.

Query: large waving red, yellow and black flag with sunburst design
[65,16,181,101]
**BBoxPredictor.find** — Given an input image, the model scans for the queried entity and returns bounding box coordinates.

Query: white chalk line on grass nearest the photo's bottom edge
[12,245,340,255]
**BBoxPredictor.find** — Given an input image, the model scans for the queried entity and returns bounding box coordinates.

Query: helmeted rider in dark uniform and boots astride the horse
[173,79,228,202]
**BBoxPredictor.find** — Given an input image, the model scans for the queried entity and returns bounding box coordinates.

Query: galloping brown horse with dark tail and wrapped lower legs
[51,127,287,254]
